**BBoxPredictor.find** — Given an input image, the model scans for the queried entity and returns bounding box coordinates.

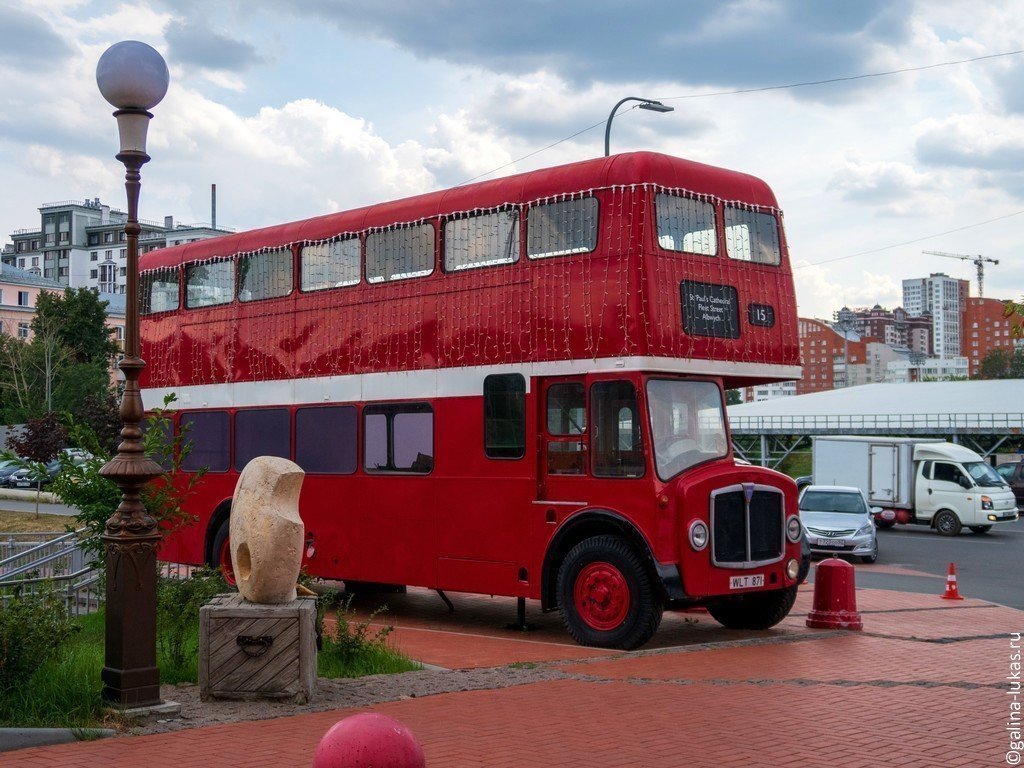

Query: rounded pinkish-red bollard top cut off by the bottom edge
[312,712,427,768]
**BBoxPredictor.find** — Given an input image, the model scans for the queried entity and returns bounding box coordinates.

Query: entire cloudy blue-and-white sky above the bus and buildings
[0,0,1024,316]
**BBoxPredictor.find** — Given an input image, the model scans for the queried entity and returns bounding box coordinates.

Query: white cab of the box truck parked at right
[913,442,1018,536]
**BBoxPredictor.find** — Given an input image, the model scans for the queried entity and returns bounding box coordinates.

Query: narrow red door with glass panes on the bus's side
[538,376,589,505]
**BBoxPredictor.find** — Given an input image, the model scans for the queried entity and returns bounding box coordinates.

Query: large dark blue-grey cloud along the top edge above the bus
[275,0,911,97]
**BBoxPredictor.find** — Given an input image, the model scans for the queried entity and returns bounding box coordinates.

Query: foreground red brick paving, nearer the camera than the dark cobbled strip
[8,679,1005,768]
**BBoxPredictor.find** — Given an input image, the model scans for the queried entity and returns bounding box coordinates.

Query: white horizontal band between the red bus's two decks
[142,357,801,409]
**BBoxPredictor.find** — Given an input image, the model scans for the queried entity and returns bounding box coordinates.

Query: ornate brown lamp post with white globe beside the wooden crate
[96,40,170,709]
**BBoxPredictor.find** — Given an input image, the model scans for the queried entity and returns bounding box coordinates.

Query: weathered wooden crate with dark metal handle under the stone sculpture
[199,593,316,703]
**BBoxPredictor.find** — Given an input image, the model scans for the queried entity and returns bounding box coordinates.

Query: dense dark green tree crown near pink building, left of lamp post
[32,288,118,370]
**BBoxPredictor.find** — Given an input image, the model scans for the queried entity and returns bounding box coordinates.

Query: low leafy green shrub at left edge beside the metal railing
[0,591,74,694]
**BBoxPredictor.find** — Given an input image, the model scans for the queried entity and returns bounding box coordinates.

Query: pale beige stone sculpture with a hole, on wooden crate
[229,456,305,603]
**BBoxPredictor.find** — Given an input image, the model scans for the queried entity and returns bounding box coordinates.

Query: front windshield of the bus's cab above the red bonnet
[647,379,728,480]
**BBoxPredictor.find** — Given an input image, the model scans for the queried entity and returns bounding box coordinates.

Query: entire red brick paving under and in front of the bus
[6,590,1024,768]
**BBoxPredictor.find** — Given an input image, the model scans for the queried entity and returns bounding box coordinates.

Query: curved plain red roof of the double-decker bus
[139,152,777,270]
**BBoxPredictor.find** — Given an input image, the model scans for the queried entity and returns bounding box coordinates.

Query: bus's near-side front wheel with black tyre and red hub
[555,536,665,650]
